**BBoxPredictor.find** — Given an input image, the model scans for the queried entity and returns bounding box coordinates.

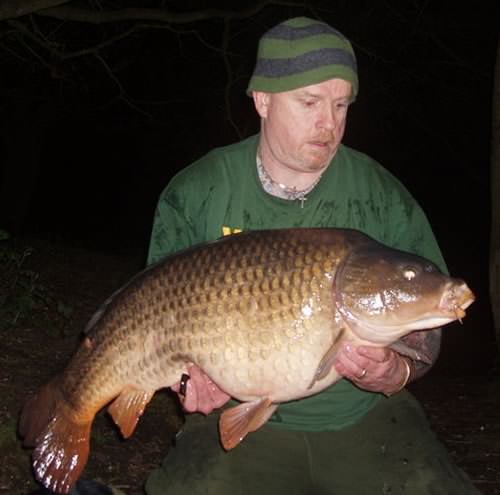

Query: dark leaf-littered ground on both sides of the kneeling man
[0,239,500,495]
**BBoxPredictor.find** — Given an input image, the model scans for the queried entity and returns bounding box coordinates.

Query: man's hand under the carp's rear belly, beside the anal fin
[171,364,231,414]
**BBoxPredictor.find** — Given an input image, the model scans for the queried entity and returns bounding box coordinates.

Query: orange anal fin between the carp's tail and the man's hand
[108,387,154,438]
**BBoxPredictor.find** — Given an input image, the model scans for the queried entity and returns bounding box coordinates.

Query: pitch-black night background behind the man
[0,0,500,372]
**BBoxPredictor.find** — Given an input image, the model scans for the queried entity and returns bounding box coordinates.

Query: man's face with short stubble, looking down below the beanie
[253,79,351,172]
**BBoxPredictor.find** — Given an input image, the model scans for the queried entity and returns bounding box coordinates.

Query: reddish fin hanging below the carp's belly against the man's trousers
[219,397,278,450]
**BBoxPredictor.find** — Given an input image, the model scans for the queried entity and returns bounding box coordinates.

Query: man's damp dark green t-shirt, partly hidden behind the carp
[148,136,446,431]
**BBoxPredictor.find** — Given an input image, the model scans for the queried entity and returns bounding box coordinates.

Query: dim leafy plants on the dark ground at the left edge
[0,240,73,331]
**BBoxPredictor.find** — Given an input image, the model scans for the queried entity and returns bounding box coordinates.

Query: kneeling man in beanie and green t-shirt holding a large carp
[142,17,477,495]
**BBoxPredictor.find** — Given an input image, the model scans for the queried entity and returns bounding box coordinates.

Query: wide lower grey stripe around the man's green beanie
[254,48,356,77]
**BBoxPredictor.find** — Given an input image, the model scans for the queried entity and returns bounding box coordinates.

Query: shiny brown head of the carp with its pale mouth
[333,243,474,345]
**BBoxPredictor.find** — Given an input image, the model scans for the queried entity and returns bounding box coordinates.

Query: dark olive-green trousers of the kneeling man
[145,391,479,495]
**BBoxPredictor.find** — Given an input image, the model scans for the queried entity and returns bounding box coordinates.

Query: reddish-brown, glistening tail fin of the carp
[19,382,91,494]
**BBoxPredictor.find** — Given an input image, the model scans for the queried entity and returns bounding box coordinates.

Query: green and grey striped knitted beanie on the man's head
[247,17,359,101]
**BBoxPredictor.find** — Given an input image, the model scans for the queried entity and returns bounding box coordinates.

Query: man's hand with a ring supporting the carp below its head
[335,344,410,395]
